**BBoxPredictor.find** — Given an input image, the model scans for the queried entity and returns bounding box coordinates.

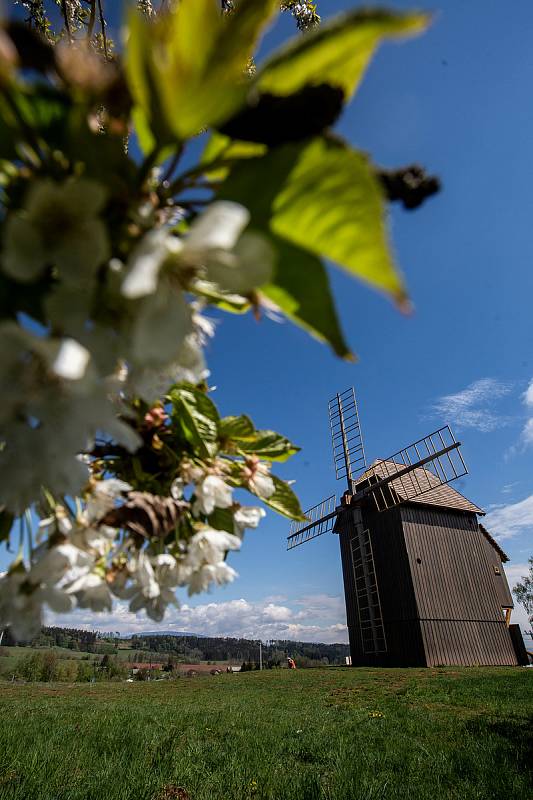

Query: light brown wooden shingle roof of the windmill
[356,460,485,514]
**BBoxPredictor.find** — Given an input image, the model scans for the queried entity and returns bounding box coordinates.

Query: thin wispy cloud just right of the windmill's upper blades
[431,378,512,435]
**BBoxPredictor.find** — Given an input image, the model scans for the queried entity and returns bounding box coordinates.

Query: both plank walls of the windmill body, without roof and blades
[337,503,517,666]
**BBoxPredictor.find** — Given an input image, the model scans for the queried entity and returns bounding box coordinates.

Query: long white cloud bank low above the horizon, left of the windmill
[47,595,348,643]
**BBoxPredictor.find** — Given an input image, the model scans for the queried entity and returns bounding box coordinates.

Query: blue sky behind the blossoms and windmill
[4,0,533,641]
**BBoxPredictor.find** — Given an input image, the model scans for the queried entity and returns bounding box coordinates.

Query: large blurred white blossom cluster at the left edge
[0,322,140,513]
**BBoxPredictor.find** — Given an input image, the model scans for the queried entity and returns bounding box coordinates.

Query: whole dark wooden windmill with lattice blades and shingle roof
[287,389,517,666]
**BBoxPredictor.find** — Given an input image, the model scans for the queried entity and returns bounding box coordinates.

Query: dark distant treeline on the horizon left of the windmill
[131,634,350,666]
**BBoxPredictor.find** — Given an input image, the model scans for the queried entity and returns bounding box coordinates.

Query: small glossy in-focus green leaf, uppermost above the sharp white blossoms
[168,386,219,457]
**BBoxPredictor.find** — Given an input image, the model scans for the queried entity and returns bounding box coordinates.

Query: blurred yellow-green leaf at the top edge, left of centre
[126,0,279,145]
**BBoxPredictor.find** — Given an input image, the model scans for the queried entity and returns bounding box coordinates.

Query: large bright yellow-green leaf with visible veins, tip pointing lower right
[220,137,406,303]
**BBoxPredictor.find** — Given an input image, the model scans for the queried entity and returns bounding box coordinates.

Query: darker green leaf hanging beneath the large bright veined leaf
[261,236,356,361]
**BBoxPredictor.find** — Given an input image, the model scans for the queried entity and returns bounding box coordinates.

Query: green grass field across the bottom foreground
[0,668,533,800]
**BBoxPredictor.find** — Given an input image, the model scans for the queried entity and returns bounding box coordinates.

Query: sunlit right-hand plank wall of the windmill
[401,506,516,666]
